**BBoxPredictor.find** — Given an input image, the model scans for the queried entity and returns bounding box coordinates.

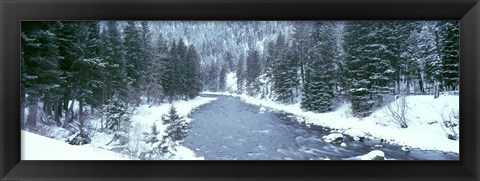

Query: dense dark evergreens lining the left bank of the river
[21,21,202,135]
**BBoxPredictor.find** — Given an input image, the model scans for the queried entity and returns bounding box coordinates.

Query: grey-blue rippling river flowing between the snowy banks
[184,95,459,160]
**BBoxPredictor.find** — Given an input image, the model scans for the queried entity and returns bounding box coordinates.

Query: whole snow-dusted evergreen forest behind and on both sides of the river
[21,21,460,160]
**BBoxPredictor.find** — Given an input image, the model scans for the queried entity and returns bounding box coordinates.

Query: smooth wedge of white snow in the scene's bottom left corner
[21,130,128,160]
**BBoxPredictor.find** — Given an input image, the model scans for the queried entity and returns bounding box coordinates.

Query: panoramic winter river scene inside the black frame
[20,20,461,161]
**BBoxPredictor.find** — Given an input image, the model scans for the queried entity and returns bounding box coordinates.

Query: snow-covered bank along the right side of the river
[203,92,460,153]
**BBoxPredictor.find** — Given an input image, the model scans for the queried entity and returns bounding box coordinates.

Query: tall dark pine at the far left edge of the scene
[21,22,62,128]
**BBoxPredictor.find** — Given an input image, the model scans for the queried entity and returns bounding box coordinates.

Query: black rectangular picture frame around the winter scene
[0,0,480,181]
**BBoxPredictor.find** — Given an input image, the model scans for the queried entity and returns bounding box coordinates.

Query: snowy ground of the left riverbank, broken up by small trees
[22,96,216,160]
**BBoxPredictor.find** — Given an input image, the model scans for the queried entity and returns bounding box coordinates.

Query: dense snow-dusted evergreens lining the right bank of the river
[236,21,459,117]
